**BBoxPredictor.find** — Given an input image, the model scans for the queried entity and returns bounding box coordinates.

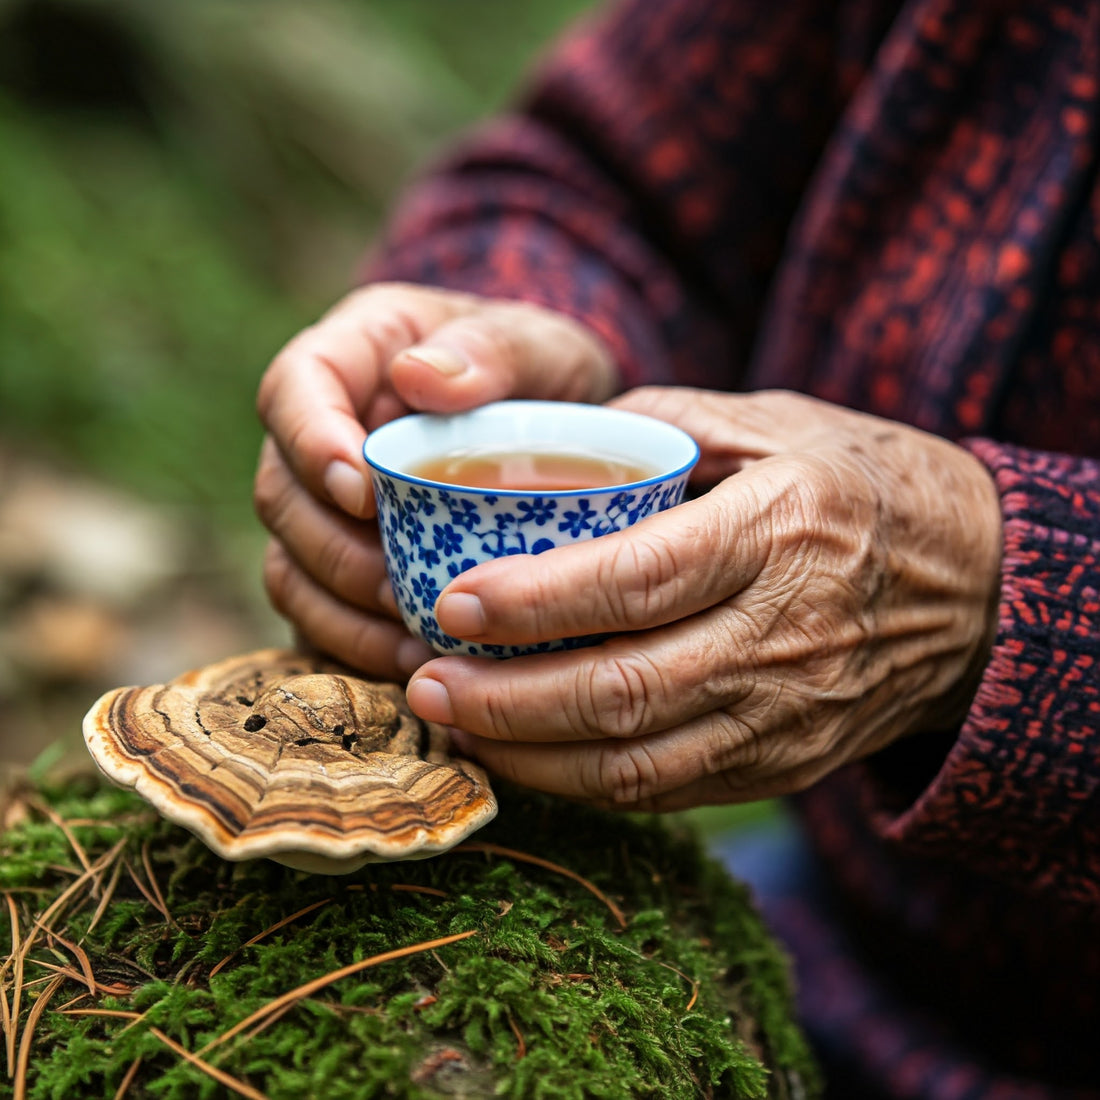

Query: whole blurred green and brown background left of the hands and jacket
[0,0,586,765]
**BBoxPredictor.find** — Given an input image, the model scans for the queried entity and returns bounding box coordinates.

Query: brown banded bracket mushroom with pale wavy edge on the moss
[84,649,496,875]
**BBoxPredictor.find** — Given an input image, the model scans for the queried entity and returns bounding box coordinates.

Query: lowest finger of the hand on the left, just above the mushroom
[264,540,435,680]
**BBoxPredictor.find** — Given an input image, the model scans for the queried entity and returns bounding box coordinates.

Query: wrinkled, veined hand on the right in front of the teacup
[408,387,1001,810]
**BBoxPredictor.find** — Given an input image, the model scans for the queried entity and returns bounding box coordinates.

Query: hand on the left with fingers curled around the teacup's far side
[255,283,617,680]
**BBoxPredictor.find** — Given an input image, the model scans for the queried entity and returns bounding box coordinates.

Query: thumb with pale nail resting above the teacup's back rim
[389,301,618,413]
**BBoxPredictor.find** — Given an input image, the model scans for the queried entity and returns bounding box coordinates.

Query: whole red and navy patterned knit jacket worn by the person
[370,0,1100,1100]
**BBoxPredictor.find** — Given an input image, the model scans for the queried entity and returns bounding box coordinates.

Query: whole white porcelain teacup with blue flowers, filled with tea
[363,400,699,657]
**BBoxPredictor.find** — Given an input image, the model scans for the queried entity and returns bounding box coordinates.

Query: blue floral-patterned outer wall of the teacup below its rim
[373,470,688,657]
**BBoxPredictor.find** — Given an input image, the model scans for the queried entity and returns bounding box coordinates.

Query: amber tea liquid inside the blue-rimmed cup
[409,448,658,493]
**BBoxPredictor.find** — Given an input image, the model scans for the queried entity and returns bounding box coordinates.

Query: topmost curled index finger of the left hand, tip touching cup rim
[256,285,468,517]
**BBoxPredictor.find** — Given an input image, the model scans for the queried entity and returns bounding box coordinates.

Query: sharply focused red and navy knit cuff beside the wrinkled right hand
[871,440,1100,909]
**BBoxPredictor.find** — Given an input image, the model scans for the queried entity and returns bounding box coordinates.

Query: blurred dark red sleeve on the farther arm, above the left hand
[365,0,898,388]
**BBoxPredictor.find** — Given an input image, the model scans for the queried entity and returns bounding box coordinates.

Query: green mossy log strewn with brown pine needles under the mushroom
[0,779,820,1100]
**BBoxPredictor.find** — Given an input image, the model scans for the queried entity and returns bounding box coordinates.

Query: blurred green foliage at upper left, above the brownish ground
[0,0,587,525]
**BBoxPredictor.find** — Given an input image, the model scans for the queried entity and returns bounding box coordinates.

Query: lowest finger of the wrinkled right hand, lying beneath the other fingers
[446,713,785,809]
